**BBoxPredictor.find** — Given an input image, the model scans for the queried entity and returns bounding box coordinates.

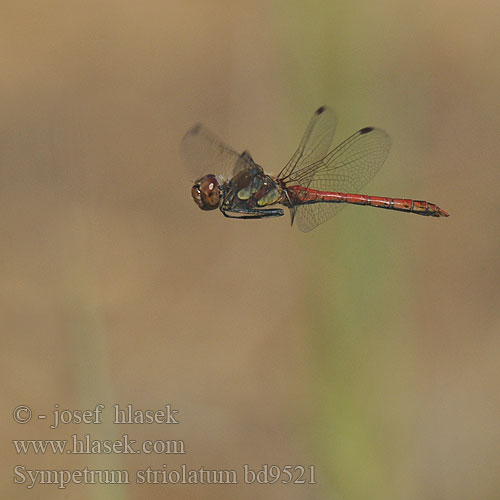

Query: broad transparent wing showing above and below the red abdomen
[287,127,391,232]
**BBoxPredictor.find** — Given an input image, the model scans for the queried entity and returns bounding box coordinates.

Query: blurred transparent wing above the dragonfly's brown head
[181,123,253,178]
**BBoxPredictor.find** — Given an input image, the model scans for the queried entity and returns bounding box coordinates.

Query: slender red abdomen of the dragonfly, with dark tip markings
[287,186,449,217]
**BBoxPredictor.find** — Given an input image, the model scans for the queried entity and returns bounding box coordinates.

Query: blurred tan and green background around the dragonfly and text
[0,0,500,500]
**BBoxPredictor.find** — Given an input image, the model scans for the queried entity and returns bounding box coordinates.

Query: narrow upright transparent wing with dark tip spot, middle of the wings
[278,106,337,181]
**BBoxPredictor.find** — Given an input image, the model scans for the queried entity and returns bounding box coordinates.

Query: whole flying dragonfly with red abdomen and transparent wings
[181,106,449,232]
